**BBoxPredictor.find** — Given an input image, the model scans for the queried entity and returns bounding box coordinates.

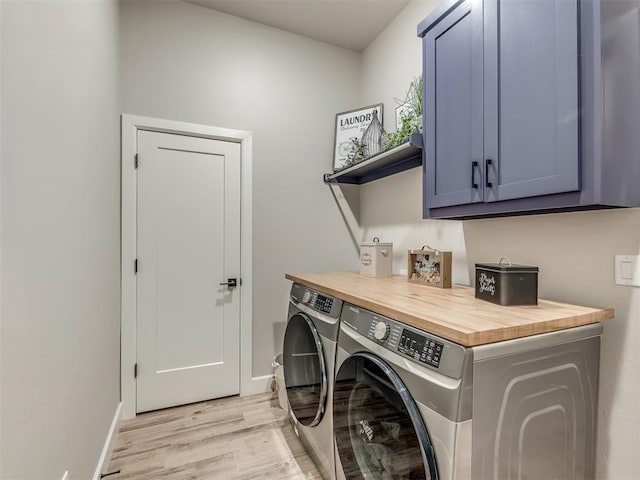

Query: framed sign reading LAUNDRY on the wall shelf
[333,103,383,171]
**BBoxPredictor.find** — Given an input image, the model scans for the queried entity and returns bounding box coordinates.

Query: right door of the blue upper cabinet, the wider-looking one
[484,0,580,202]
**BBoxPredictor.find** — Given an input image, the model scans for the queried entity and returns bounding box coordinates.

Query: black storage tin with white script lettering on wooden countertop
[476,260,538,305]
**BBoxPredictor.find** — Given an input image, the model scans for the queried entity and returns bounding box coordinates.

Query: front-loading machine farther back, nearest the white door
[282,283,343,480]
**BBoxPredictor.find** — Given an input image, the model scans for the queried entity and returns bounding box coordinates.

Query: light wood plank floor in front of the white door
[105,393,322,480]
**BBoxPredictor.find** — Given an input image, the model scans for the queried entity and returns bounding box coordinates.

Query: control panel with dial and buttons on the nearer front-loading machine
[340,303,466,378]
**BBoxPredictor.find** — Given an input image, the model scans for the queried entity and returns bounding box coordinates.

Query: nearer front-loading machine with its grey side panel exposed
[333,303,602,480]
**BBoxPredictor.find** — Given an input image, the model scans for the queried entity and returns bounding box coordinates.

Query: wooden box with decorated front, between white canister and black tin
[407,246,452,288]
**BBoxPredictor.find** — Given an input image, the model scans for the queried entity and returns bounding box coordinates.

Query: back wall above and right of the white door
[120,1,360,376]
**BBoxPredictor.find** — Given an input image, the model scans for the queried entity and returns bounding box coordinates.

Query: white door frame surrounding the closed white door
[120,114,255,419]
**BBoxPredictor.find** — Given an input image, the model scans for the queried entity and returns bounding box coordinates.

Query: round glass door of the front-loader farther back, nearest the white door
[282,313,328,427]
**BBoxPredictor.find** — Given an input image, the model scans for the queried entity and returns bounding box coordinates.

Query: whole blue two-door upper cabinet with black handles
[418,0,640,218]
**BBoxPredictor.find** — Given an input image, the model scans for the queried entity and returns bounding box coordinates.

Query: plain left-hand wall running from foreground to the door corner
[0,0,120,480]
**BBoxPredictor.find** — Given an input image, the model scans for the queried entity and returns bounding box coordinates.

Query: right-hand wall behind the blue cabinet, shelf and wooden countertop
[360,0,640,480]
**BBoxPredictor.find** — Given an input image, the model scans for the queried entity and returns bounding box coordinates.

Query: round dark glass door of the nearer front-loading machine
[333,353,438,480]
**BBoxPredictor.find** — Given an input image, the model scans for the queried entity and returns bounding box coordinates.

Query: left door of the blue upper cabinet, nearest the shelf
[423,0,483,208]
